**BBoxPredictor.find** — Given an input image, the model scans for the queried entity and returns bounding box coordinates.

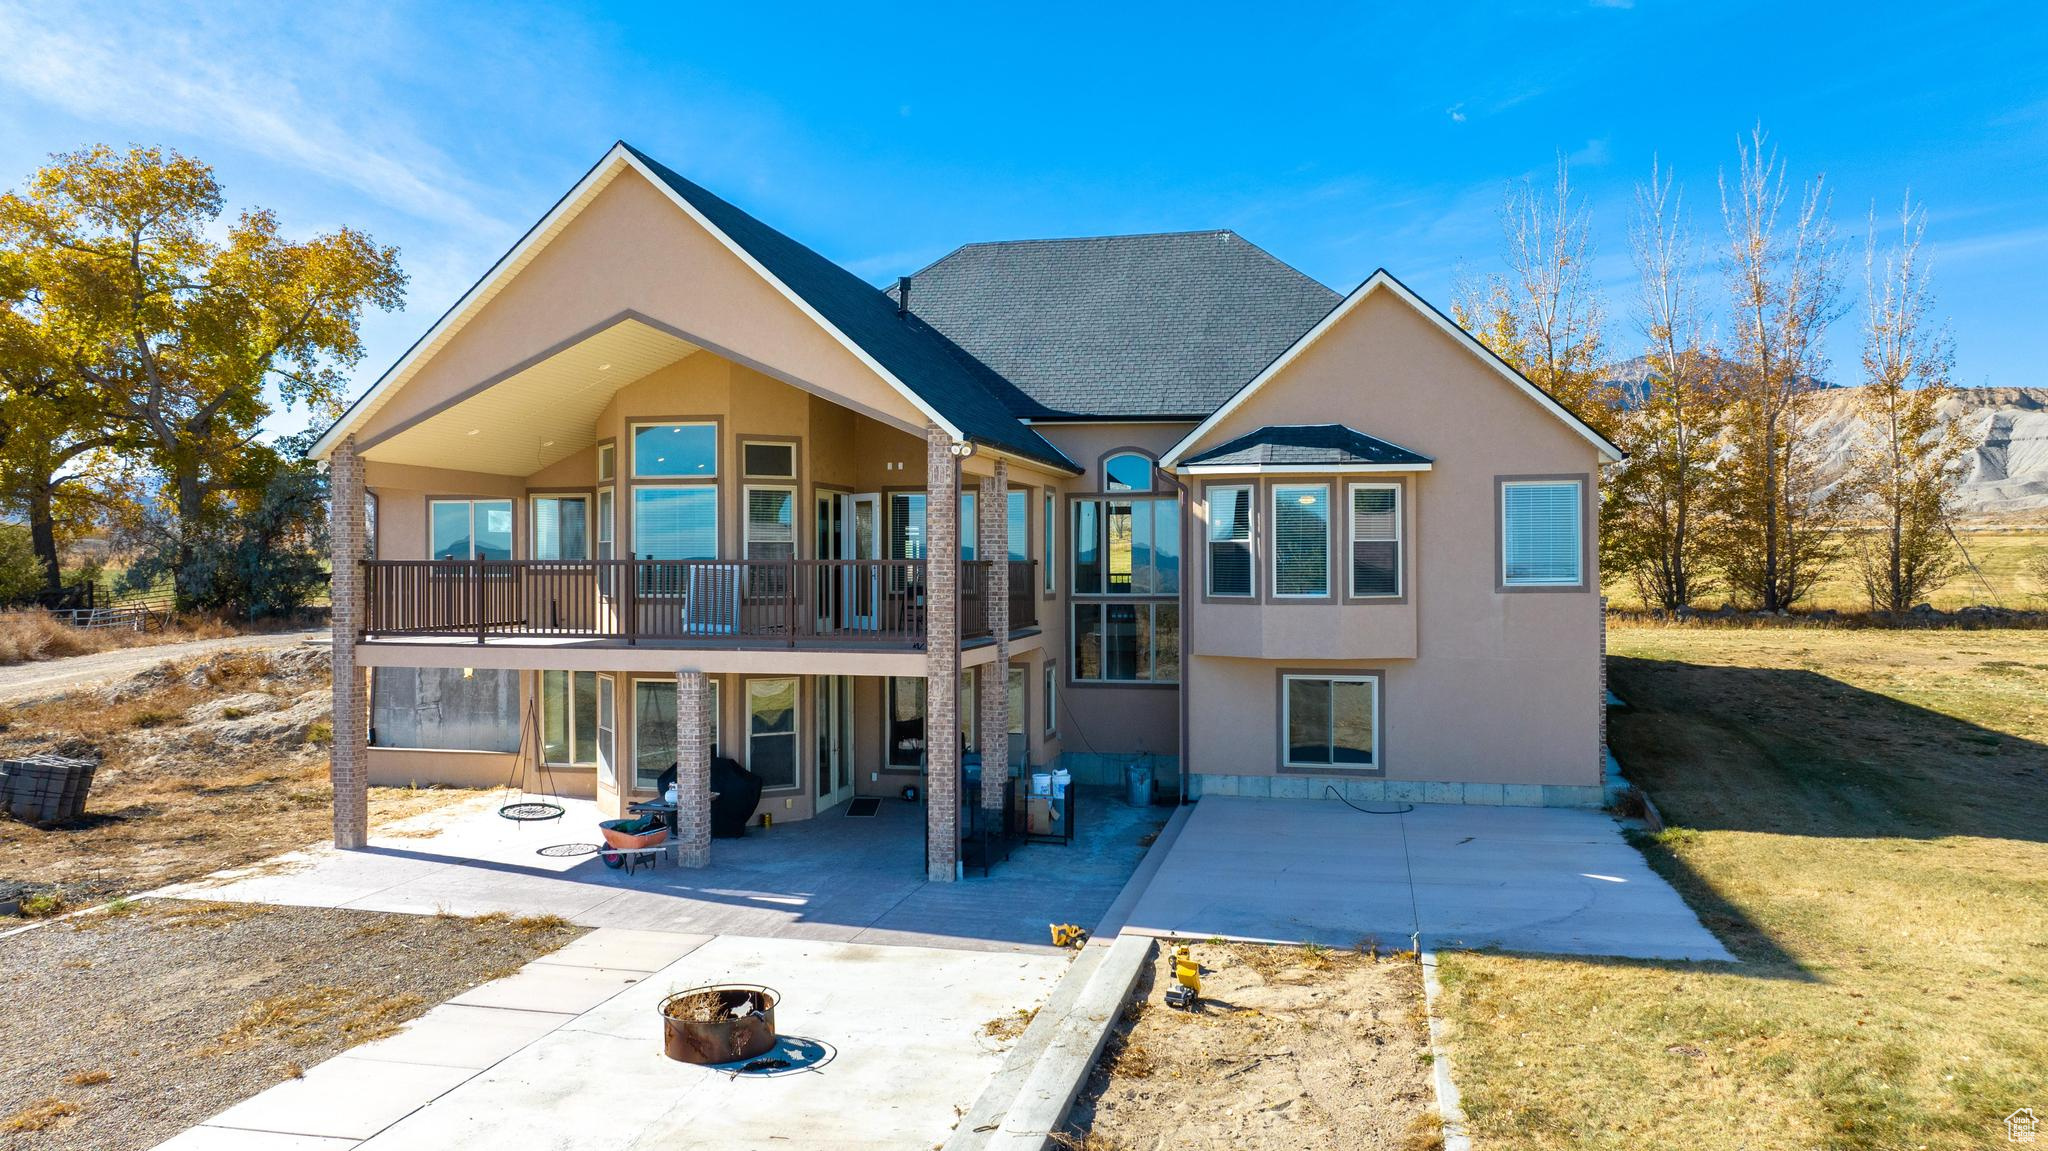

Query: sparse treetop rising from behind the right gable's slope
[1452,156,1610,424]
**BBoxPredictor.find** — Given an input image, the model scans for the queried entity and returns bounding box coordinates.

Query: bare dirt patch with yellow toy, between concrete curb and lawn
[1067,942,1442,1151]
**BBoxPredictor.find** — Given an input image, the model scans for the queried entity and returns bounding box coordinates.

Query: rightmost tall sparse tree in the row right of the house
[1851,195,1970,614]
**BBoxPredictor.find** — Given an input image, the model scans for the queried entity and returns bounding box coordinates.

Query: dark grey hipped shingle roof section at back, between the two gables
[891,231,1341,420]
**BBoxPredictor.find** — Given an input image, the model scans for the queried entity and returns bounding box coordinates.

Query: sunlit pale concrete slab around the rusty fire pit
[160,928,1067,1151]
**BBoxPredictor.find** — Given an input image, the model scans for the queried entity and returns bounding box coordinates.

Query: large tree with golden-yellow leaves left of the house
[0,145,406,606]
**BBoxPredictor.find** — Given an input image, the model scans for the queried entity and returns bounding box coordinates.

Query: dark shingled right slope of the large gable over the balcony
[625,143,1081,467]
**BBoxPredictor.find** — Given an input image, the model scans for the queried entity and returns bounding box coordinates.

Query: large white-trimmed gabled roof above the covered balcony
[307,141,1079,471]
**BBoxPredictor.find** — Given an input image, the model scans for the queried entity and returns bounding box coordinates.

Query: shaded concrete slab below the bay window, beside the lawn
[1126,797,1735,961]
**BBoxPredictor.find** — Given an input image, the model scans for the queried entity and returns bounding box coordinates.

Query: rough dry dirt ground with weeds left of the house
[0,647,475,913]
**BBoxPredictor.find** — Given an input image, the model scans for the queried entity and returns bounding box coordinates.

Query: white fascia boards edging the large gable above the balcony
[307,143,967,459]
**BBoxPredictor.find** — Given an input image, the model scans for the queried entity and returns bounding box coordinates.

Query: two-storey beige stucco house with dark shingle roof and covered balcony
[313,143,1618,879]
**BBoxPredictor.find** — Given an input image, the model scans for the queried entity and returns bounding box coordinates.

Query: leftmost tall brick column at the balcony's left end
[328,436,371,850]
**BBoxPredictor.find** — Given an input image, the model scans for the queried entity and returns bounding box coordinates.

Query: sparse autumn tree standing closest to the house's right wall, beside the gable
[1599,160,1726,610]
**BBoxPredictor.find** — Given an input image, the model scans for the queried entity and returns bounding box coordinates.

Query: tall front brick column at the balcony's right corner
[924,424,961,883]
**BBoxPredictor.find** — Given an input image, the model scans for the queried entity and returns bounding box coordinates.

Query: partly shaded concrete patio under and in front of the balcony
[162,788,1169,950]
